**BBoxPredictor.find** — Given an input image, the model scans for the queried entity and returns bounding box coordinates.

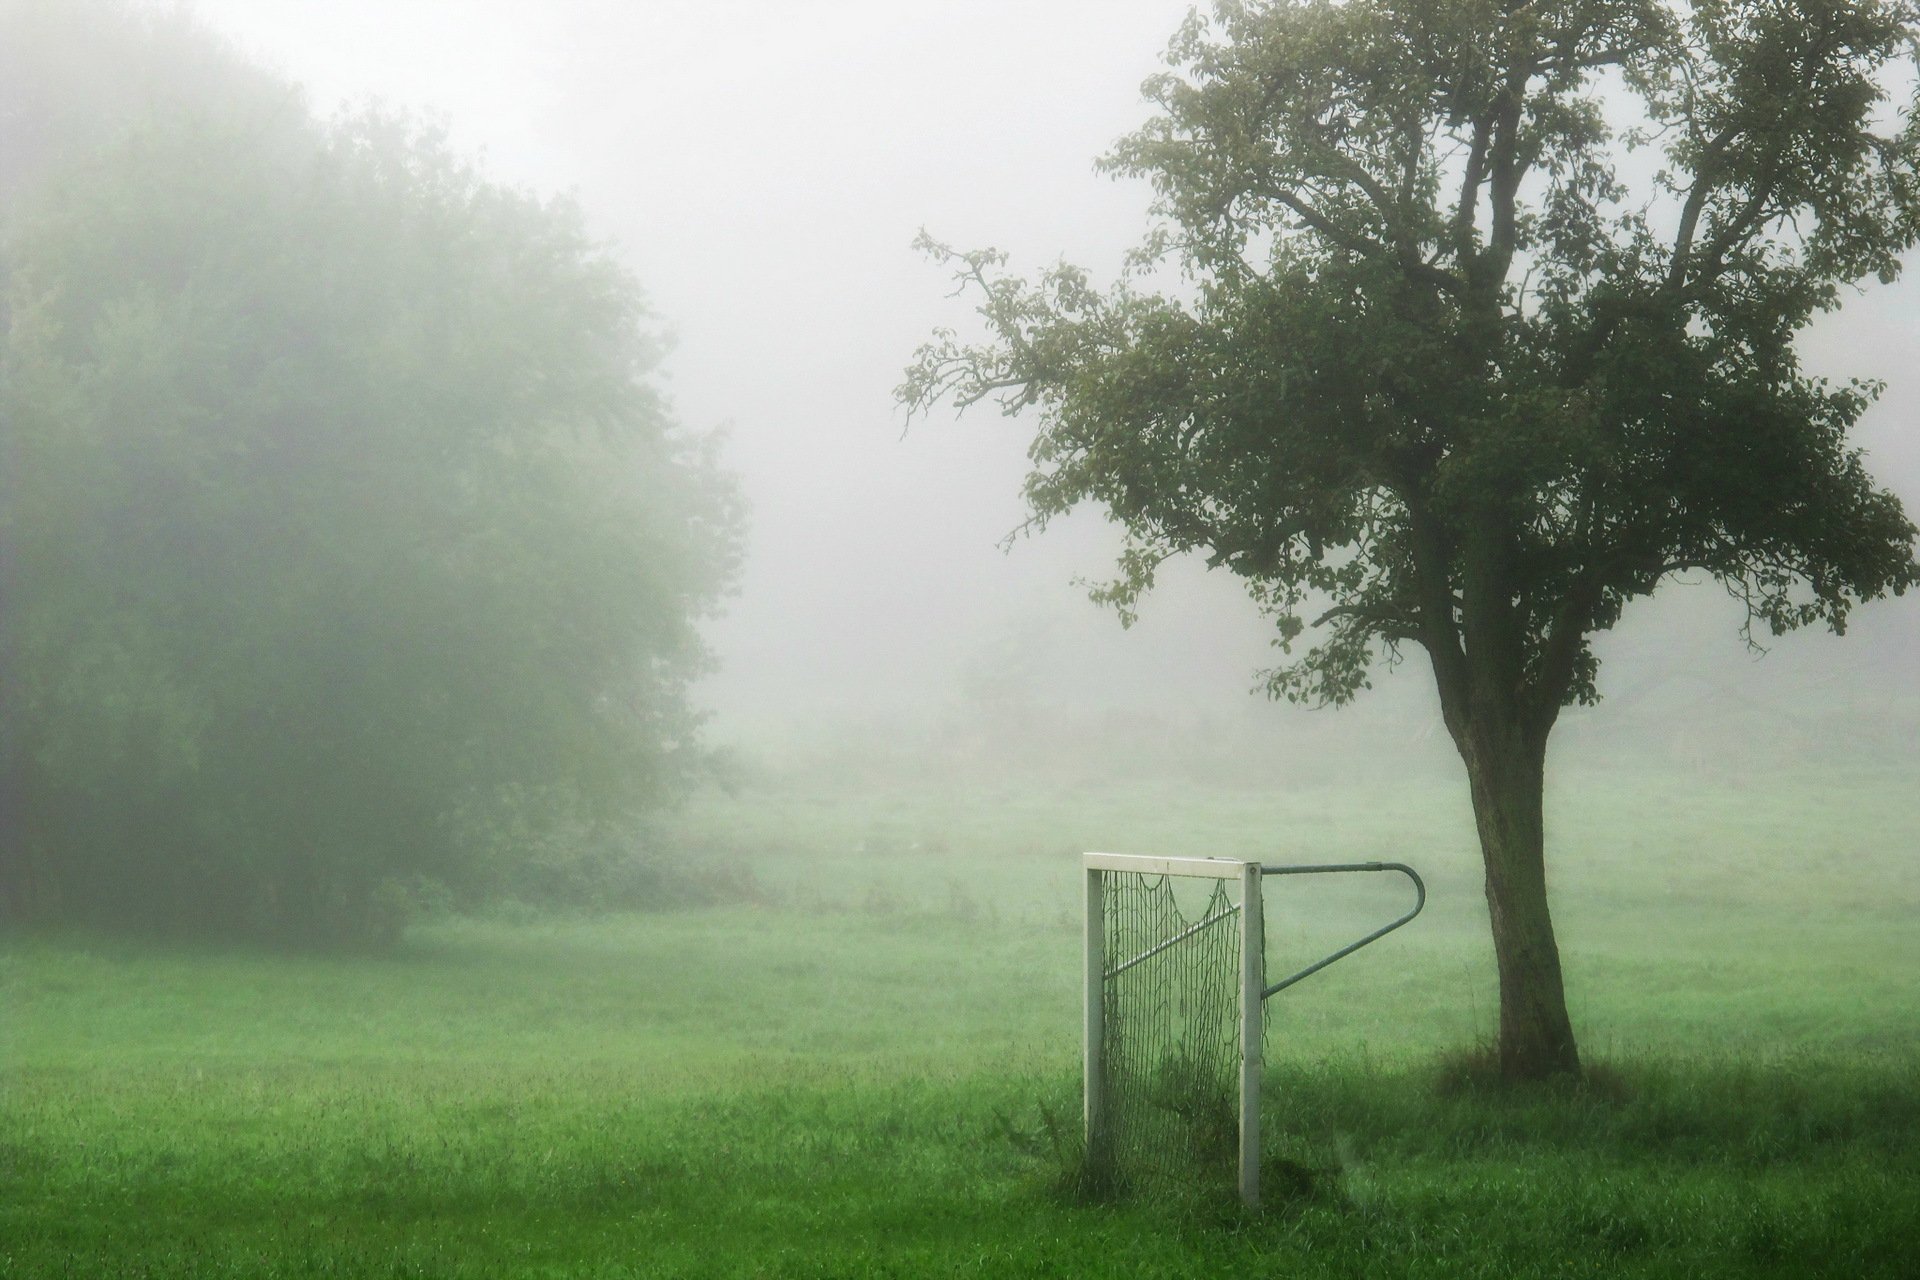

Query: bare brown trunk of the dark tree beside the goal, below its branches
[1459,725,1580,1080]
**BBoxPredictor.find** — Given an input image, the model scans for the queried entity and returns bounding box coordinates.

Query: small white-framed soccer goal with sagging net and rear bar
[1081,854,1427,1207]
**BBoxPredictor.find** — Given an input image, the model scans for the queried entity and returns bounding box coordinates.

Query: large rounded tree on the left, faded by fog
[0,7,737,940]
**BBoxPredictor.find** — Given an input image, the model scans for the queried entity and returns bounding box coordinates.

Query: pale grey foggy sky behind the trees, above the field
[172,0,1920,752]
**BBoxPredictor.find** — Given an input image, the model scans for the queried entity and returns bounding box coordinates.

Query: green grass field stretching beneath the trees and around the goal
[0,771,1920,1278]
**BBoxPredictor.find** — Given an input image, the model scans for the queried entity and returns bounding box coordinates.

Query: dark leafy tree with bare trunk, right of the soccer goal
[900,0,1920,1079]
